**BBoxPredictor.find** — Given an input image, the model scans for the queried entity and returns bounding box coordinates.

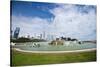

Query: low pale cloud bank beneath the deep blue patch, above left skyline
[12,16,48,36]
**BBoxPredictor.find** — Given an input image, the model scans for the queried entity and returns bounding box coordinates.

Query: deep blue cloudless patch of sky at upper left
[12,1,57,19]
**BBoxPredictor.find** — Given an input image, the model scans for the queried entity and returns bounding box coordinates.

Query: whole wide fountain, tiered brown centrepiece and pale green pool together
[11,38,96,53]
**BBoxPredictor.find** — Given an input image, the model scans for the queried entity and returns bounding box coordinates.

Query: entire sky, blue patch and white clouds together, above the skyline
[11,1,96,40]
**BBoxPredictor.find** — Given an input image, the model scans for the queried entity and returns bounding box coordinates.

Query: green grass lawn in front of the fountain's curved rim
[11,50,96,66]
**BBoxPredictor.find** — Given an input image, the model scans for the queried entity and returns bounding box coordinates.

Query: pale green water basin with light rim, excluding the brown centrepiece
[13,42,96,53]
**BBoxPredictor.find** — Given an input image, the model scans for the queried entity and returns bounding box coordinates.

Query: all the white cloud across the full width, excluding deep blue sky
[12,4,96,40]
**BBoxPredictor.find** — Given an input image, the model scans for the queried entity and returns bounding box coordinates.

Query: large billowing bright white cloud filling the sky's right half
[51,5,96,40]
